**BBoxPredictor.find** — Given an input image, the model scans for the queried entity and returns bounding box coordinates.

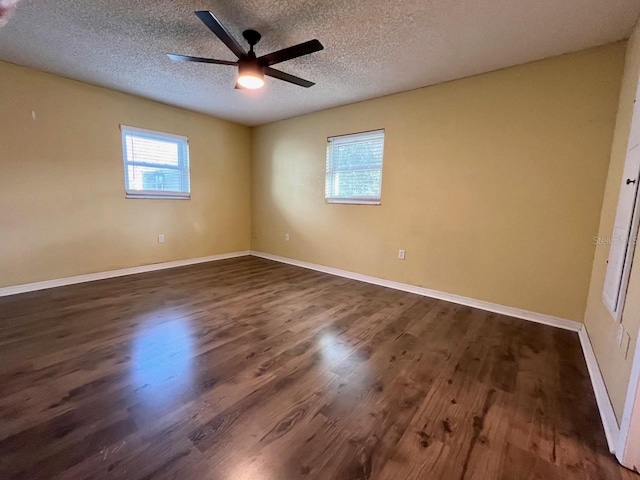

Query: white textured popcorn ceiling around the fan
[0,0,640,125]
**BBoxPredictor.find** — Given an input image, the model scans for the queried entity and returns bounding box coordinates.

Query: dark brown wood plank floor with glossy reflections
[0,257,638,480]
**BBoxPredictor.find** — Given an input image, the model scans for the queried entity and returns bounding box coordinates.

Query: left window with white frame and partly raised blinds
[120,125,191,199]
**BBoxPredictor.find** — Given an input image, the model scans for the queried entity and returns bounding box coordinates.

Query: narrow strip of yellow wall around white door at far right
[585,21,640,419]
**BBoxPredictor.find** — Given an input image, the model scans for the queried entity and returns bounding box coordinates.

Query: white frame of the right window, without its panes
[324,128,386,205]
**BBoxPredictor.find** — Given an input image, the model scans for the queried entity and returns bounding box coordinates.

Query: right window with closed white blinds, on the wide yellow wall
[325,130,384,205]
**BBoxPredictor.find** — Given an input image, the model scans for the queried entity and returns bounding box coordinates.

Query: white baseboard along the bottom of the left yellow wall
[0,250,251,297]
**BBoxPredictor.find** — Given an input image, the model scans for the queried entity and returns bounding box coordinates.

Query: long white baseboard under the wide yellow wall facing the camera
[251,250,582,332]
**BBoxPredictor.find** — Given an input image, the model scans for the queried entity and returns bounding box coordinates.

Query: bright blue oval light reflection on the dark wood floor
[131,312,194,406]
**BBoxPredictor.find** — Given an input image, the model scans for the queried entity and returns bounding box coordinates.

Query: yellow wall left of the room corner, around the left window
[0,62,251,286]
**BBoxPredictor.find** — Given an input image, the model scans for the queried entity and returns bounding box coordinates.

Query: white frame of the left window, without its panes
[120,125,191,200]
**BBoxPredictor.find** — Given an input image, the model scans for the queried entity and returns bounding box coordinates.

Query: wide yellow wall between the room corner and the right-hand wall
[252,43,625,321]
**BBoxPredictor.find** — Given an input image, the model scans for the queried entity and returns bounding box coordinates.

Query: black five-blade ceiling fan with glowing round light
[168,10,324,90]
